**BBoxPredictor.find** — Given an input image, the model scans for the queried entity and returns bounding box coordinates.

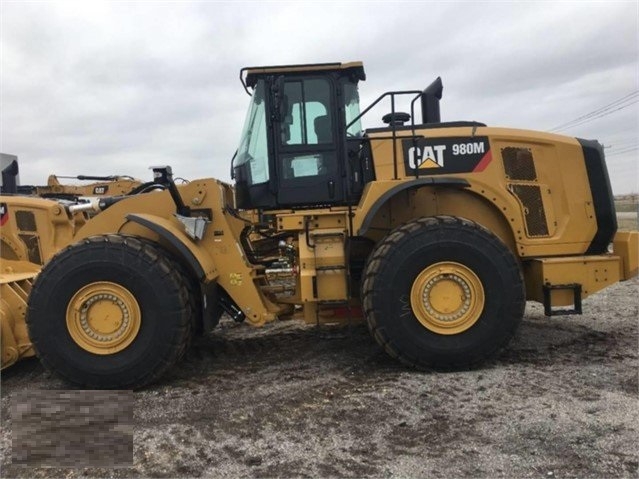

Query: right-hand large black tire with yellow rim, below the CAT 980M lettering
[362,216,525,370]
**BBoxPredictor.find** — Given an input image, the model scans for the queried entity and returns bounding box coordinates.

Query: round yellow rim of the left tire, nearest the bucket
[67,281,142,355]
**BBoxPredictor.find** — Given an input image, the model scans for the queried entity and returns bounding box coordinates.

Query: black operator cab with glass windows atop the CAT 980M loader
[232,62,366,209]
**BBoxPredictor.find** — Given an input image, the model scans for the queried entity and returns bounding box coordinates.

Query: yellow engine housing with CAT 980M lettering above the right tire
[355,127,616,258]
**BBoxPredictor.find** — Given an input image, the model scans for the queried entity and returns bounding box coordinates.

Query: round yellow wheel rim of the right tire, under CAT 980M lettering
[410,261,484,334]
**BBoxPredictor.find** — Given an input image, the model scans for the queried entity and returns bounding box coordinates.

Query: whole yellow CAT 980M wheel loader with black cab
[2,62,637,388]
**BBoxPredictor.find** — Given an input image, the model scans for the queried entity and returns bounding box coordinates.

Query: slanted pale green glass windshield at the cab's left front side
[235,80,269,185]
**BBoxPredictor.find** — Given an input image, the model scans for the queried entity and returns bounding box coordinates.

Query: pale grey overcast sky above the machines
[0,1,639,194]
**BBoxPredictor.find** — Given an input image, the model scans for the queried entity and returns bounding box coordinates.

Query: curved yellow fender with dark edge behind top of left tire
[126,214,218,281]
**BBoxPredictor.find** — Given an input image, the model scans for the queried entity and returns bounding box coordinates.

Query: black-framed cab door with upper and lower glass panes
[274,76,344,206]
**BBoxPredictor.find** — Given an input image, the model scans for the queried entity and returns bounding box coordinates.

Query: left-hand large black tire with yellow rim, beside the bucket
[27,235,192,389]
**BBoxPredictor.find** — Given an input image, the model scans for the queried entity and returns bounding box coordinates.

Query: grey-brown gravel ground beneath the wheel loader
[0,279,639,478]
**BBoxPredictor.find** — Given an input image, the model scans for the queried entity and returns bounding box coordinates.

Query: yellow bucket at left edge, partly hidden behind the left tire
[0,259,40,369]
